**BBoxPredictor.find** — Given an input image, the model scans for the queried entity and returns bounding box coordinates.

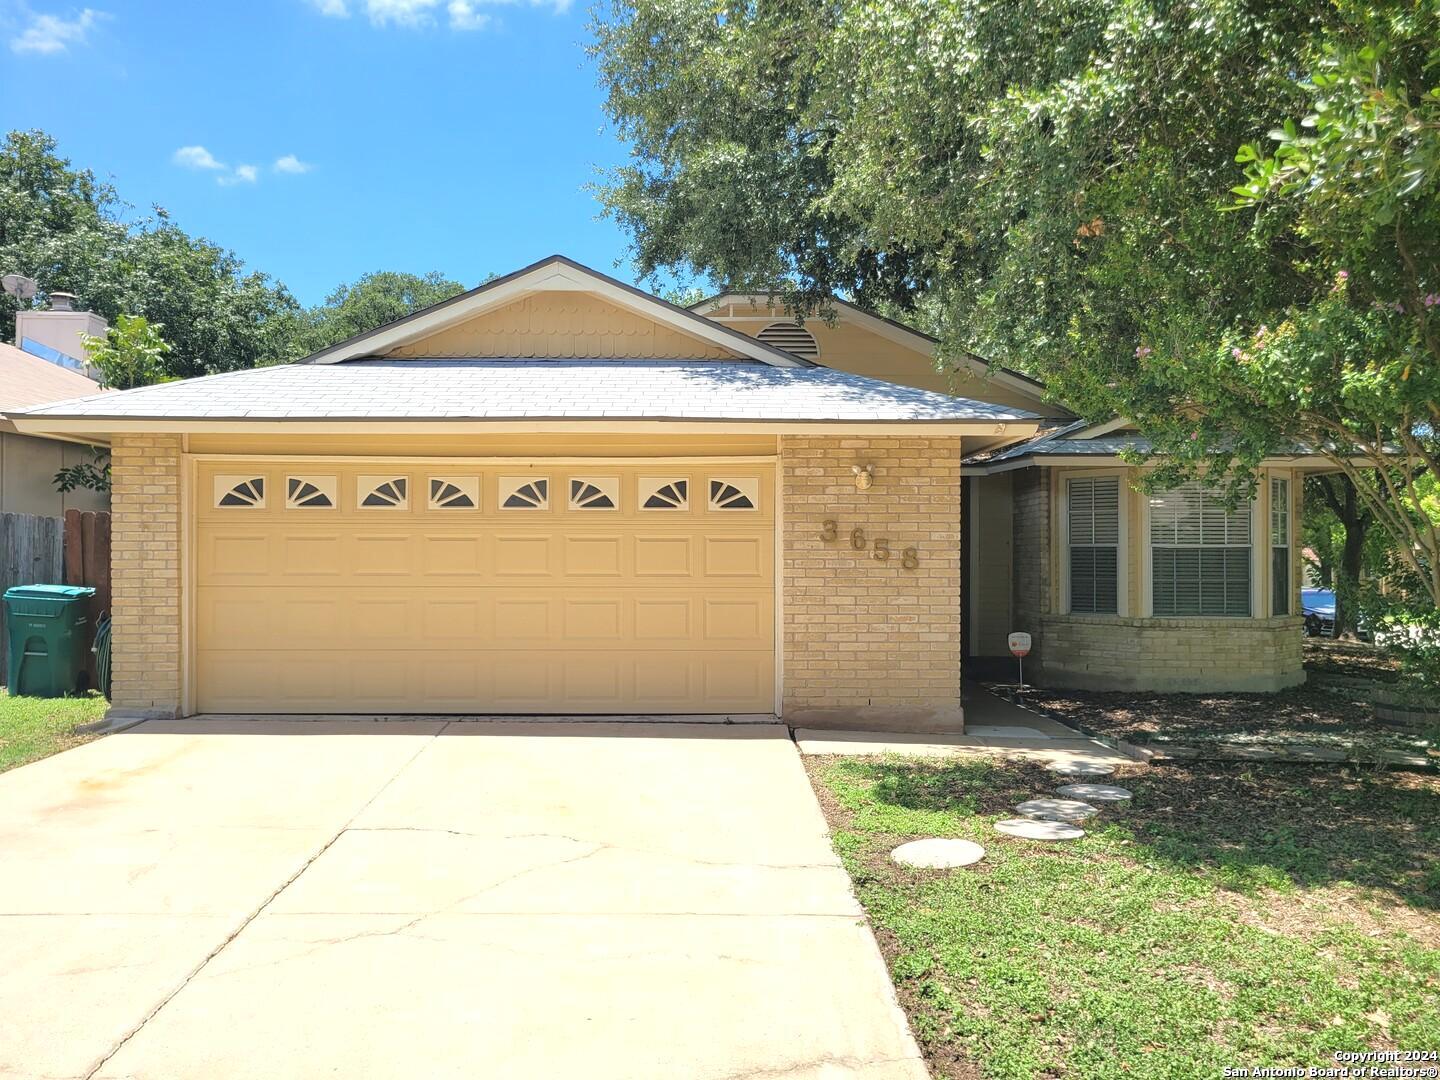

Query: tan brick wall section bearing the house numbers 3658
[780,436,960,730]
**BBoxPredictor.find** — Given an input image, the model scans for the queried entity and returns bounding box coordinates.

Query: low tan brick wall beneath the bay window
[1038,615,1305,693]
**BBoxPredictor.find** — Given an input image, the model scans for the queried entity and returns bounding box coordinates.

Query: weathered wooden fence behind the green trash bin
[0,510,109,685]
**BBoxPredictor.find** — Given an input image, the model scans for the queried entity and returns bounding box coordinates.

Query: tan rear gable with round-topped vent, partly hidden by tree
[696,297,1071,418]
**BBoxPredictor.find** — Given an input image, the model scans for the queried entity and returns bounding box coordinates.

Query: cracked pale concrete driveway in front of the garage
[0,719,926,1080]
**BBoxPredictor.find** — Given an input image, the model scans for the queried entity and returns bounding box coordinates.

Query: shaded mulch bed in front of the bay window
[1025,642,1440,763]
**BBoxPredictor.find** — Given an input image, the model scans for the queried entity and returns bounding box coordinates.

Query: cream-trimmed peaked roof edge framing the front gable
[300,255,814,367]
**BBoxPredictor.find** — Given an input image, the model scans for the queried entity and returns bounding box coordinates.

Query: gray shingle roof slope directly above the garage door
[16,360,1038,422]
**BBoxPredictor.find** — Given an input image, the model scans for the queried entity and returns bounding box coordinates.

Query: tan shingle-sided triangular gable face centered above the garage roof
[382,291,739,360]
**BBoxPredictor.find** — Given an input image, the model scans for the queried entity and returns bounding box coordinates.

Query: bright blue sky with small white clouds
[0,0,653,304]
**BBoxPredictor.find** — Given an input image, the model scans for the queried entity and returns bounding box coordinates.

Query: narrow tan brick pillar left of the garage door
[111,435,181,714]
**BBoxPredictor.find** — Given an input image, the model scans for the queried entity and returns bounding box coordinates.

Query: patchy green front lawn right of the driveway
[811,759,1440,1080]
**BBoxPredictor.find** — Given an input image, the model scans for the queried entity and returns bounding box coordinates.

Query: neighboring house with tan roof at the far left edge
[0,344,109,517]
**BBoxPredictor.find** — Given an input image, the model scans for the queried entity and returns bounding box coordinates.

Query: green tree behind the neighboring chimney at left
[0,131,301,377]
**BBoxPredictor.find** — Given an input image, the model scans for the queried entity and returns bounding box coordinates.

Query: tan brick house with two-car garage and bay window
[19,256,1319,730]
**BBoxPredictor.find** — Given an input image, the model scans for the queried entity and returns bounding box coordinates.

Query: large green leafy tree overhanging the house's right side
[593,0,1440,602]
